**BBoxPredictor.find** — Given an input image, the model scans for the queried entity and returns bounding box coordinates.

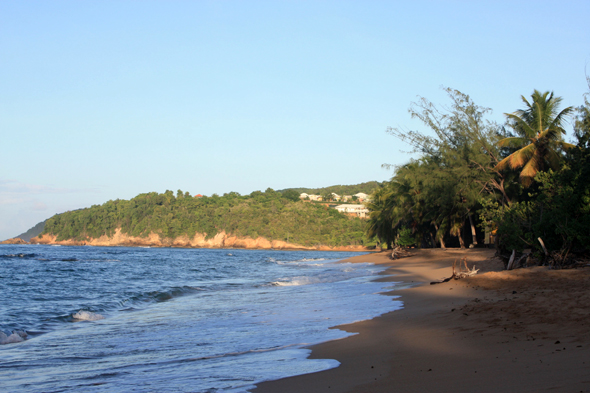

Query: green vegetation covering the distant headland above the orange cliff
[43,189,366,246]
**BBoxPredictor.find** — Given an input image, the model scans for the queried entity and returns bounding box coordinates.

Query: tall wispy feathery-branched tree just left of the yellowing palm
[376,88,510,247]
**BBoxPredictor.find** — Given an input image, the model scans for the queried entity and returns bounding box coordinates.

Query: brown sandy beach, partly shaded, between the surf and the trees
[253,249,590,393]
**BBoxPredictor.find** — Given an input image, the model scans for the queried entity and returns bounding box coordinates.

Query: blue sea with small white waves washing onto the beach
[0,245,401,392]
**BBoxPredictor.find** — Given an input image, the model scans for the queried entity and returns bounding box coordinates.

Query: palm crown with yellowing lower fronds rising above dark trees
[496,90,574,187]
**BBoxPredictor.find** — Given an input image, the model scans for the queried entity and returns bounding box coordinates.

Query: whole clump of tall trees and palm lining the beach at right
[367,80,590,264]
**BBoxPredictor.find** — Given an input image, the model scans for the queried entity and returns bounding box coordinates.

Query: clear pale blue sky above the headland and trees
[0,0,590,240]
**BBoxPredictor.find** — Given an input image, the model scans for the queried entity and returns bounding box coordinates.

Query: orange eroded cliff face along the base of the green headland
[31,228,369,251]
